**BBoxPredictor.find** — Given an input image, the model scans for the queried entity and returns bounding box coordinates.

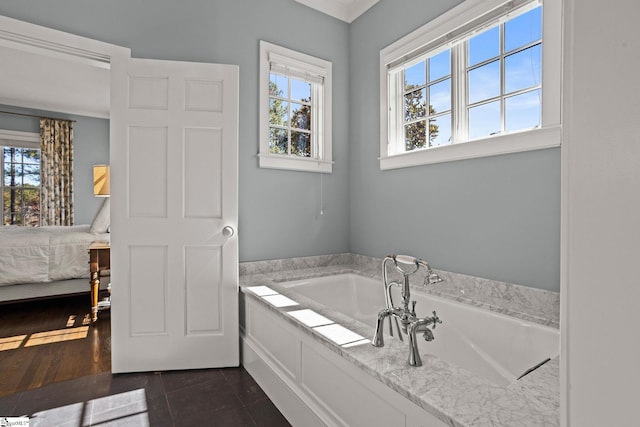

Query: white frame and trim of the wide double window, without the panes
[379,0,562,170]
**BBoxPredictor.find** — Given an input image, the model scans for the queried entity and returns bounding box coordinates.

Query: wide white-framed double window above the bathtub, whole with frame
[380,0,561,169]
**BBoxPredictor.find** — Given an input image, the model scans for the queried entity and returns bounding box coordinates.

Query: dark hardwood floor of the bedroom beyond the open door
[0,295,111,396]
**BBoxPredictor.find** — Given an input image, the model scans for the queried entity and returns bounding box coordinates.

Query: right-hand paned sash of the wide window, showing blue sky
[464,6,542,140]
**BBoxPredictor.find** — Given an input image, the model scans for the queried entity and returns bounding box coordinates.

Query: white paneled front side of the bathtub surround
[240,295,445,427]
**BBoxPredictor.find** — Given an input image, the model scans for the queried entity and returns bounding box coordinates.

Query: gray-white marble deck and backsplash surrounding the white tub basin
[240,254,560,427]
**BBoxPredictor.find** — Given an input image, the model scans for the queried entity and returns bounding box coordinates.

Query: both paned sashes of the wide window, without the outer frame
[398,6,542,152]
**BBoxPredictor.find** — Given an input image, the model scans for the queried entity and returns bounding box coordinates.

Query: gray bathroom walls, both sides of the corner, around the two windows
[0,0,560,290]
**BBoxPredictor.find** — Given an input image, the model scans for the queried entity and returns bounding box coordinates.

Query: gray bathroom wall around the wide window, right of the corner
[349,0,560,291]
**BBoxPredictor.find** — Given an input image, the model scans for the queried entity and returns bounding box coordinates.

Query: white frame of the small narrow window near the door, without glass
[258,40,333,173]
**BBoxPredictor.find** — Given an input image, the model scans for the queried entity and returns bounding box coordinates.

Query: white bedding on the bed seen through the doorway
[0,225,109,286]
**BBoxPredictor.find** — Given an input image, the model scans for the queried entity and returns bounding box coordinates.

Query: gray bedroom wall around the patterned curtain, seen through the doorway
[0,105,109,224]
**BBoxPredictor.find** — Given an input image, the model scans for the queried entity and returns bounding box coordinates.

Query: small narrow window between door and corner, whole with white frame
[259,41,333,173]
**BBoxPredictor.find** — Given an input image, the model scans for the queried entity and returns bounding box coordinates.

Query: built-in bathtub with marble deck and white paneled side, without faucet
[240,266,559,427]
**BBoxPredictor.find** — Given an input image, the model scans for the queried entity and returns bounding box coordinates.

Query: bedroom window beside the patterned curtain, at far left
[0,131,40,226]
